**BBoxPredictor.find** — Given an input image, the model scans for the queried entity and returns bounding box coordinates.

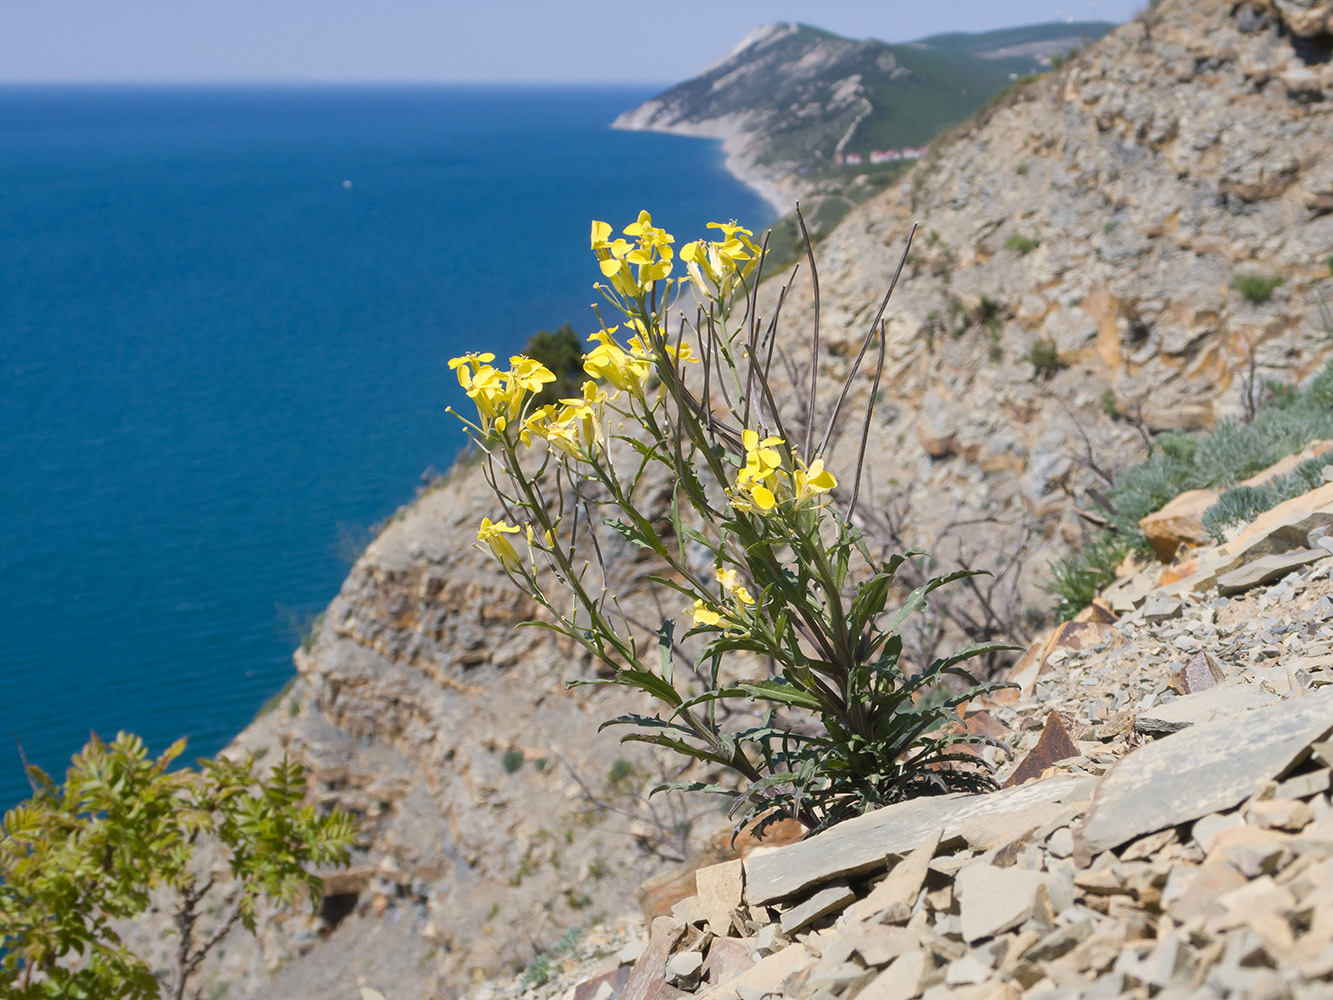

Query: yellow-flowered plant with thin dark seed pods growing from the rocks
[449,212,1009,829]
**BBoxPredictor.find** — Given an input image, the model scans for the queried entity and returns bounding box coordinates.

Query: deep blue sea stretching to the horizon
[0,87,773,807]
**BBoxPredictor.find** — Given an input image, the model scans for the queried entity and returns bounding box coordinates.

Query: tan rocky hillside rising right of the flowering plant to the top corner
[751,0,1333,642]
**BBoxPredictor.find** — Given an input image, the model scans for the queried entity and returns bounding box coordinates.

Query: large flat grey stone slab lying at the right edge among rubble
[1077,687,1333,853]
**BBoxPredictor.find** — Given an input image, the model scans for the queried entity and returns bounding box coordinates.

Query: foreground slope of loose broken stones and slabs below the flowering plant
[453,467,1333,1000]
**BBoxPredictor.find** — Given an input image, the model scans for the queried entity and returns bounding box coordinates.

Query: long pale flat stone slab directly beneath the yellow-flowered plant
[745,777,1093,905]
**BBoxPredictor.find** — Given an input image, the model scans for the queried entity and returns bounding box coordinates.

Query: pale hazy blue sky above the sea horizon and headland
[0,0,1144,83]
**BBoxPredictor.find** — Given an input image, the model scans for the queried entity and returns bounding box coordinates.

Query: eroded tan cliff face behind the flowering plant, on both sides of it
[190,0,1333,997]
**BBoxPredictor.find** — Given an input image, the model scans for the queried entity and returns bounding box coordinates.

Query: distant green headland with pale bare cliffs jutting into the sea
[613,21,1114,212]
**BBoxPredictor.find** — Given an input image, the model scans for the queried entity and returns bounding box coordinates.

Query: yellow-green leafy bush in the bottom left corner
[0,733,355,1000]
